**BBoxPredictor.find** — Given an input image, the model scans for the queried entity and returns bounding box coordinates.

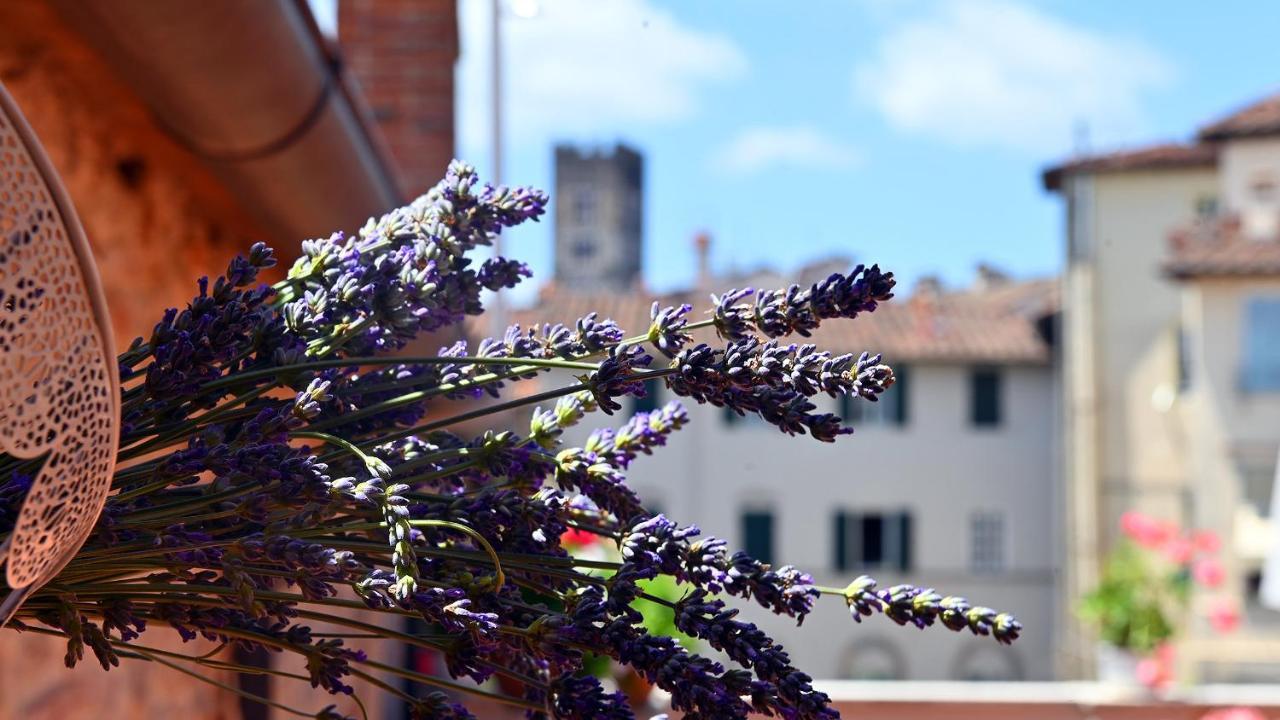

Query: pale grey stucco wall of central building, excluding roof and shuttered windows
[555,365,1060,679]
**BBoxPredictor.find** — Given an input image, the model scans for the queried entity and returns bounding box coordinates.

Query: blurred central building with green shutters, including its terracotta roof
[516,221,1060,680]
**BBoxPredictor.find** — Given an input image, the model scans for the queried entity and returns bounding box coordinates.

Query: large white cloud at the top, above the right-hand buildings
[854,0,1172,152]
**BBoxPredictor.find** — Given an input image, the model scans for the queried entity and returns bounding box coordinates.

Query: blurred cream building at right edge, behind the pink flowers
[1043,96,1280,682]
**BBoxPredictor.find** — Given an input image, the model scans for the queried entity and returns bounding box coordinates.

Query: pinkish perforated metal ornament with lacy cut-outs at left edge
[0,86,120,609]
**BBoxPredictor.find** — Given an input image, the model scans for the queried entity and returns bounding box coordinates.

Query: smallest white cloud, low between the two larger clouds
[716,126,859,174]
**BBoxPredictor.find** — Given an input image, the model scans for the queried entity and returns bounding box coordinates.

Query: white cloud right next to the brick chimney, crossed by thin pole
[458,0,746,155]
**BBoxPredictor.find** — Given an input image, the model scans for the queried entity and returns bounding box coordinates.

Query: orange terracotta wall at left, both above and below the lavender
[0,3,260,720]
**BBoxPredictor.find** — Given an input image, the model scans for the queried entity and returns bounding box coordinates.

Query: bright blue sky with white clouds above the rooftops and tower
[427,0,1280,299]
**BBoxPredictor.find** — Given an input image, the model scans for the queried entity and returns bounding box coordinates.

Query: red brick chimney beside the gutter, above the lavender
[338,0,458,199]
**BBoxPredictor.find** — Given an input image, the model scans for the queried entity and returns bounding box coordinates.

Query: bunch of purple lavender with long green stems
[0,163,1020,719]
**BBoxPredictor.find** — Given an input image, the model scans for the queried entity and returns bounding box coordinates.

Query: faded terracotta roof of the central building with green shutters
[494,274,1057,364]
